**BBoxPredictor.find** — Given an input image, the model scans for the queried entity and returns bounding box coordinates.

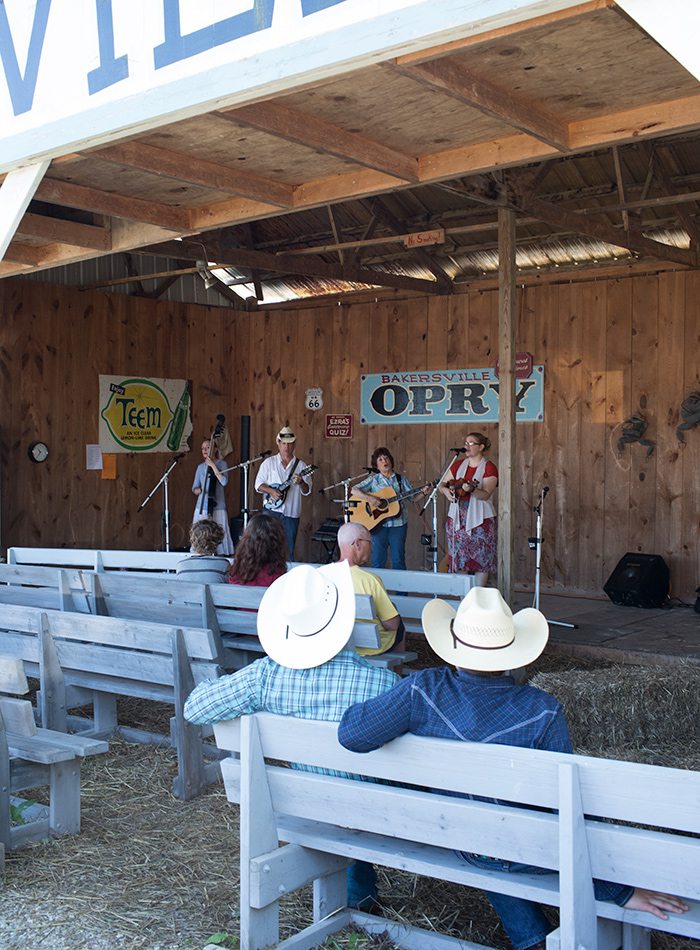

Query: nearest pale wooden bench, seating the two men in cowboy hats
[214,713,700,950]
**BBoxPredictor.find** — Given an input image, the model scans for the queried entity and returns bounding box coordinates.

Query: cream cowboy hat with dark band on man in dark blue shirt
[421,587,549,673]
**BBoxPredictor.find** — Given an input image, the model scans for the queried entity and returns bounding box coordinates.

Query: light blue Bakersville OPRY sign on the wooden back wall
[361,365,544,425]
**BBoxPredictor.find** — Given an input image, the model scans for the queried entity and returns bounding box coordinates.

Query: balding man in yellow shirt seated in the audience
[338,522,406,656]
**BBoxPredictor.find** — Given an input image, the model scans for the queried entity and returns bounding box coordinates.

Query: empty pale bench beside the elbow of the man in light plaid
[0,604,220,799]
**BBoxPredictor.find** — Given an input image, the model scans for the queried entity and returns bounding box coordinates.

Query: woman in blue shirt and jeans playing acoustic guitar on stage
[352,446,412,571]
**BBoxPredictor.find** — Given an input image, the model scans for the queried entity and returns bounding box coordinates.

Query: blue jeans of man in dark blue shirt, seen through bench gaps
[456,851,633,950]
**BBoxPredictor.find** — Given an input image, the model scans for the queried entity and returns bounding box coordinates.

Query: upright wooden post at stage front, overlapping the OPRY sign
[498,208,515,604]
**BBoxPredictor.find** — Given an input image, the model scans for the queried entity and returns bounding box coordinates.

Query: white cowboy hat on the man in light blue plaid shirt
[258,561,355,670]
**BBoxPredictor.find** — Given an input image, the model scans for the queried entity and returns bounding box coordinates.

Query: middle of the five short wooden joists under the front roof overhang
[89,141,294,208]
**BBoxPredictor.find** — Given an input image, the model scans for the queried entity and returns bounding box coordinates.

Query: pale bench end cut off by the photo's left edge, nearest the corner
[0,656,109,852]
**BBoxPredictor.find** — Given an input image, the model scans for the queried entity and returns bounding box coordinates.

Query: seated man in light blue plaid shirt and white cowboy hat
[185,563,399,910]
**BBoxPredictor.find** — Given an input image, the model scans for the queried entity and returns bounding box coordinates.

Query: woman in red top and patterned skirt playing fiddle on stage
[440,432,498,587]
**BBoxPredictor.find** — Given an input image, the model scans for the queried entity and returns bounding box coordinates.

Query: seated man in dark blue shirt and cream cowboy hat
[338,587,688,950]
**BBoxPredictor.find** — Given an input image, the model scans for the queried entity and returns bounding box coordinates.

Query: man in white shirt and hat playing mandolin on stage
[255,426,315,560]
